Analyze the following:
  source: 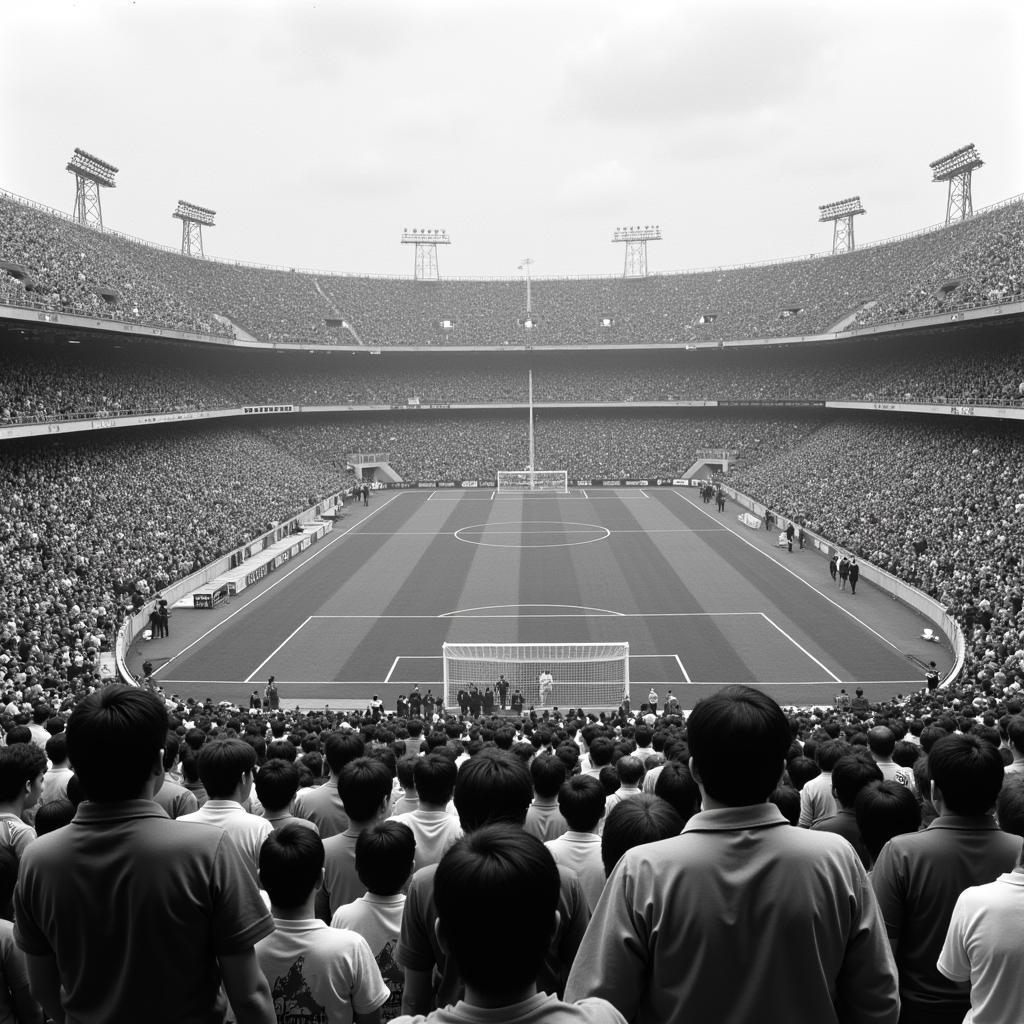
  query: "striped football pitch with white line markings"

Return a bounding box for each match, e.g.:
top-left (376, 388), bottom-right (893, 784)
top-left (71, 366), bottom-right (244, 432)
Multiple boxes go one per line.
top-left (146, 487), bottom-right (951, 709)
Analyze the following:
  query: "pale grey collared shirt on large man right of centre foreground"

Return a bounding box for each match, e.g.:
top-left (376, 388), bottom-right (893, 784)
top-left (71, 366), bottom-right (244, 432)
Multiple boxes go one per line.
top-left (565, 804), bottom-right (899, 1024)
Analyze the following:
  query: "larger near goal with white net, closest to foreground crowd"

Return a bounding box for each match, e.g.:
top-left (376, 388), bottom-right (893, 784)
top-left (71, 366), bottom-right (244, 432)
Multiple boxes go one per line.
top-left (442, 643), bottom-right (630, 709)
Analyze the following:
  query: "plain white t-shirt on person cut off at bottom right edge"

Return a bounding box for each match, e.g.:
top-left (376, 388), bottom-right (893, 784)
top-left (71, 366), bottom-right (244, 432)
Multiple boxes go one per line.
top-left (936, 870), bottom-right (1024, 1024)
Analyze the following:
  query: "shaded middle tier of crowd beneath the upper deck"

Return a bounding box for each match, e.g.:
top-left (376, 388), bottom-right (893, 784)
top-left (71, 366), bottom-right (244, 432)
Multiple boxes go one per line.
top-left (0, 332), bottom-right (1024, 423)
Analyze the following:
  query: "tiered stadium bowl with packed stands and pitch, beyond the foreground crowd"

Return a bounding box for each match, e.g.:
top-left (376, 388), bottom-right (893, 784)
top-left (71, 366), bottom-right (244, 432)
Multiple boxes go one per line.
top-left (0, 165), bottom-right (1024, 710)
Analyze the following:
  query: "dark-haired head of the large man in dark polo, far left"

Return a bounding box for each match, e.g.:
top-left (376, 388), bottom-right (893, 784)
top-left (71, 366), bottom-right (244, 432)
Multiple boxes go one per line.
top-left (67, 685), bottom-right (167, 803)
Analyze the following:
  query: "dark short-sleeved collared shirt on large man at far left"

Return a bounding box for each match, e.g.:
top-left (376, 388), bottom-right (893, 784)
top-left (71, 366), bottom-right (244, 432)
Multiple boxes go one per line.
top-left (14, 800), bottom-right (273, 1024)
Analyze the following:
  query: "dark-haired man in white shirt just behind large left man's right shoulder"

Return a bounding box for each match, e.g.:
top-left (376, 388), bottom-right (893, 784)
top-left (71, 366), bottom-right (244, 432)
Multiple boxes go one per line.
top-left (178, 738), bottom-right (273, 881)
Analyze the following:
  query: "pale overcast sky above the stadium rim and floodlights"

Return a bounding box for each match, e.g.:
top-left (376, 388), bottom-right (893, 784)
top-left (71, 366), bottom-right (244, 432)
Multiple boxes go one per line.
top-left (0, 0), bottom-right (1024, 276)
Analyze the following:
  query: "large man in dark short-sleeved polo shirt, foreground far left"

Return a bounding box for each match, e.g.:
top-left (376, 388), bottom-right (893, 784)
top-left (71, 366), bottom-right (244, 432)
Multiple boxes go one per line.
top-left (14, 686), bottom-right (275, 1024)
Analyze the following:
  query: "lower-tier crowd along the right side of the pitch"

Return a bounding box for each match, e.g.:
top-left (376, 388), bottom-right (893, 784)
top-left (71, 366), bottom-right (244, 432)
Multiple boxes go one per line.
top-left (729, 417), bottom-right (1024, 681)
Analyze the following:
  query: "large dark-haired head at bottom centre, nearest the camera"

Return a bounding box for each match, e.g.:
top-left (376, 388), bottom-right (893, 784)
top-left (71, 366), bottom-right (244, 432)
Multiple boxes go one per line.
top-left (434, 827), bottom-right (560, 995)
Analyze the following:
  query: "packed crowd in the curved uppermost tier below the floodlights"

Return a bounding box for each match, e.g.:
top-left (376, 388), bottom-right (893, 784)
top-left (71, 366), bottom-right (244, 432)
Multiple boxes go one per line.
top-left (0, 195), bottom-right (1024, 347)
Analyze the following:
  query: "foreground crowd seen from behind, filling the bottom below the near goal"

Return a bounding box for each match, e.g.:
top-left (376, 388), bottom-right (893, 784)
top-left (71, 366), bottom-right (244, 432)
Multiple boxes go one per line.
top-left (0, 678), bottom-right (1024, 1024)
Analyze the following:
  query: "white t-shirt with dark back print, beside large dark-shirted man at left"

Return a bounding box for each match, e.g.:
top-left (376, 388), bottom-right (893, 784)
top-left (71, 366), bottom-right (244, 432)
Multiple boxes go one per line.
top-left (256, 918), bottom-right (390, 1024)
